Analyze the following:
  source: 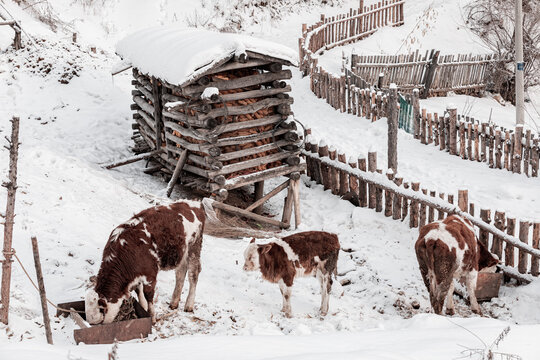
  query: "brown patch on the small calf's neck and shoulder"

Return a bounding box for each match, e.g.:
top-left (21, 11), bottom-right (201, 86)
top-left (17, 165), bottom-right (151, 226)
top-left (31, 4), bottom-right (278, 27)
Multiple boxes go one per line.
top-left (257, 243), bottom-right (296, 286)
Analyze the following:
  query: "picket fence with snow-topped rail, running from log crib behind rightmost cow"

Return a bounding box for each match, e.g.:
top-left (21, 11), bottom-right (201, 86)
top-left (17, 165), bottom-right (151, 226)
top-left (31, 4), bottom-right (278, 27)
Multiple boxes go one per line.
top-left (303, 132), bottom-right (540, 282)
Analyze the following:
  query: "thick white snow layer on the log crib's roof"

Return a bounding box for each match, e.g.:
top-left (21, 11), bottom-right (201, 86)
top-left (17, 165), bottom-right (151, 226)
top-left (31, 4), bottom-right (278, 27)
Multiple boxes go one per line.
top-left (116, 25), bottom-right (298, 85)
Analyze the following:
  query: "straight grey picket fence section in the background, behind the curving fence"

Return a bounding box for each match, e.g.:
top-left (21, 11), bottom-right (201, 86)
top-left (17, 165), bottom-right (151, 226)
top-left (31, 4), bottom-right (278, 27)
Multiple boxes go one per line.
top-left (351, 50), bottom-right (497, 98)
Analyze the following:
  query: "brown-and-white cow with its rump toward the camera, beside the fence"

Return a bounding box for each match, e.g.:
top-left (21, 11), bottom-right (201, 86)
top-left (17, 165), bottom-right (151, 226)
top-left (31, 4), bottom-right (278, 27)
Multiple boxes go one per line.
top-left (415, 215), bottom-right (499, 315)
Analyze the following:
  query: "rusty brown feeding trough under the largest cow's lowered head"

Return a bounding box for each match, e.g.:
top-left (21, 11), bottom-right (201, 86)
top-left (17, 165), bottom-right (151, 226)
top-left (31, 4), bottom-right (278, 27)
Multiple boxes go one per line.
top-left (56, 299), bottom-right (152, 344)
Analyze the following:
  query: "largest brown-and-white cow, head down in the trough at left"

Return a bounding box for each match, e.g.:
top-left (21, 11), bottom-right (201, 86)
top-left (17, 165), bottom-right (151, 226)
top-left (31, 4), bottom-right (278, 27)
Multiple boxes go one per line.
top-left (85, 200), bottom-right (205, 324)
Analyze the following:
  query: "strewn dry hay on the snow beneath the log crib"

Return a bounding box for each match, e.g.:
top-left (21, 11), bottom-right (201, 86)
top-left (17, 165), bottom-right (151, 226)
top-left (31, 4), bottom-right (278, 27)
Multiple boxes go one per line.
top-left (202, 198), bottom-right (281, 239)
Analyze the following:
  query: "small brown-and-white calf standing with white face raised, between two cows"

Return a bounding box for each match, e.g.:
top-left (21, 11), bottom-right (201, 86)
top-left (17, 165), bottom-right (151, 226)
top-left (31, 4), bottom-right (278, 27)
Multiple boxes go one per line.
top-left (244, 231), bottom-right (339, 317)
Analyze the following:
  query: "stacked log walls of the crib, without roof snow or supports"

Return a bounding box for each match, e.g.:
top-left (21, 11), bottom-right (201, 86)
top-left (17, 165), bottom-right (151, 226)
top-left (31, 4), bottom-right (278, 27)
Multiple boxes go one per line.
top-left (132, 53), bottom-right (301, 192)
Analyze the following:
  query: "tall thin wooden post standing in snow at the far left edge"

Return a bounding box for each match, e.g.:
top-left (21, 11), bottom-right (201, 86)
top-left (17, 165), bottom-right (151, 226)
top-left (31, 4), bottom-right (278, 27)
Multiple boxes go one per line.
top-left (0, 116), bottom-right (19, 325)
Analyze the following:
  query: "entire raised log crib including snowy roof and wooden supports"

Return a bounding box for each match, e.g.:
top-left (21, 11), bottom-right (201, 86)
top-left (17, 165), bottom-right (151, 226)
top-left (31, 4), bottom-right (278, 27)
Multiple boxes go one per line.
top-left (117, 26), bottom-right (305, 228)
